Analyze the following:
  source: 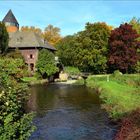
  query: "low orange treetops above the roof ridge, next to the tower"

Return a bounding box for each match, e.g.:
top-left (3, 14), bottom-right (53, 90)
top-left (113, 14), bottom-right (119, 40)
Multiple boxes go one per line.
top-left (21, 26), bottom-right (42, 37)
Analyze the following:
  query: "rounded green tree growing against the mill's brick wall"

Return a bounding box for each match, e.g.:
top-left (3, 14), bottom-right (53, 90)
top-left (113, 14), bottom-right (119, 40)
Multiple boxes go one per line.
top-left (36, 49), bottom-right (58, 78)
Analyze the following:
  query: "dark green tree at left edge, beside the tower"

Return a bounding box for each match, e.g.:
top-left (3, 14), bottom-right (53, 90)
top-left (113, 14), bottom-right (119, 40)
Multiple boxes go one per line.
top-left (0, 22), bottom-right (9, 53)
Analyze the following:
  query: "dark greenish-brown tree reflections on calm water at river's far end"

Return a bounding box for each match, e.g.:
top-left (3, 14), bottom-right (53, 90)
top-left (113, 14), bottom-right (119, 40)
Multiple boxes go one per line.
top-left (29, 85), bottom-right (100, 113)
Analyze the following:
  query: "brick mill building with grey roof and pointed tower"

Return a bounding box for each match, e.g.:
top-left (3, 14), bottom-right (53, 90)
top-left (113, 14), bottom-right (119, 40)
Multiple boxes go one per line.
top-left (2, 10), bottom-right (56, 72)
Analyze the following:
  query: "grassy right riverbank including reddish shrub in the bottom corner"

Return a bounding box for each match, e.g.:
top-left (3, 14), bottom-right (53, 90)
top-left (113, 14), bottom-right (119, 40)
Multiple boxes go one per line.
top-left (86, 75), bottom-right (140, 140)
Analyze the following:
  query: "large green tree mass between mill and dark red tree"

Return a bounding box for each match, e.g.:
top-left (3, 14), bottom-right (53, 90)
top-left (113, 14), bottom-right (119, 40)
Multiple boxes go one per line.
top-left (57, 23), bottom-right (111, 73)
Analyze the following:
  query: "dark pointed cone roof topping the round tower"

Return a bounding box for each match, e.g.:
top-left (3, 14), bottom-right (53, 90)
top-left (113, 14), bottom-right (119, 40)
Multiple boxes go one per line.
top-left (2, 10), bottom-right (19, 25)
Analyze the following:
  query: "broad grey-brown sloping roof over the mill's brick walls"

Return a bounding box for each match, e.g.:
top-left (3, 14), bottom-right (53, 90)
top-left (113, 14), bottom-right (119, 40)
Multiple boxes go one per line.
top-left (9, 31), bottom-right (56, 51)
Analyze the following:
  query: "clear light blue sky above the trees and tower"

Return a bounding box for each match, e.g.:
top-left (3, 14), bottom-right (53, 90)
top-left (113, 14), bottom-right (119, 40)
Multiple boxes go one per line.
top-left (0, 0), bottom-right (140, 36)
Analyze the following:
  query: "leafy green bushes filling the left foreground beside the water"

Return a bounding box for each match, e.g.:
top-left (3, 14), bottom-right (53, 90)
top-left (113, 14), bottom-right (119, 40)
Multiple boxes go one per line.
top-left (0, 58), bottom-right (35, 140)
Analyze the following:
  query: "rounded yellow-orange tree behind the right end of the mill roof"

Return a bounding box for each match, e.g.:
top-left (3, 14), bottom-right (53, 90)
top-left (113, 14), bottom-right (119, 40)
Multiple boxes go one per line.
top-left (43, 25), bottom-right (62, 45)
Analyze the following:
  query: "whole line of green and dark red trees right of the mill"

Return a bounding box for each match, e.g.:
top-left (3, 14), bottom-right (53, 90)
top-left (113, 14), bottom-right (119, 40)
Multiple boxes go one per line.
top-left (56, 18), bottom-right (140, 74)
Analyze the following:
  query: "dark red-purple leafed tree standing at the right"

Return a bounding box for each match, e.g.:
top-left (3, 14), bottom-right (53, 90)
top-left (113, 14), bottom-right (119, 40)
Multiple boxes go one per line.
top-left (108, 23), bottom-right (139, 73)
